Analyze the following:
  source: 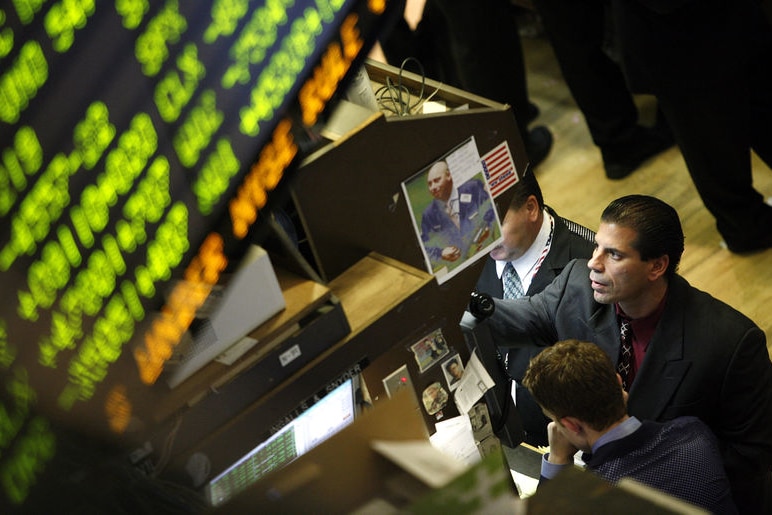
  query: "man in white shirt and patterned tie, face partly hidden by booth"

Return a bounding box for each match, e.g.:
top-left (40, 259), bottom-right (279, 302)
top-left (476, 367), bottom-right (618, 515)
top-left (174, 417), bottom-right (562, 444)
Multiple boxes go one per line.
top-left (476, 172), bottom-right (595, 445)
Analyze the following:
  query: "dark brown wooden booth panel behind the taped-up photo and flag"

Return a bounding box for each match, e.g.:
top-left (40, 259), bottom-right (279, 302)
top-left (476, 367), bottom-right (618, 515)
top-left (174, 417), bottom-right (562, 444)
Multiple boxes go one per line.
top-left (291, 61), bottom-right (527, 284)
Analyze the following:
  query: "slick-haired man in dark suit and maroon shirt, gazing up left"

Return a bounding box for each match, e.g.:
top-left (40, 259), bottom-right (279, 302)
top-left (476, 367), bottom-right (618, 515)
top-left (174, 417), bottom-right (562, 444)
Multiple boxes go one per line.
top-left (482, 195), bottom-right (772, 513)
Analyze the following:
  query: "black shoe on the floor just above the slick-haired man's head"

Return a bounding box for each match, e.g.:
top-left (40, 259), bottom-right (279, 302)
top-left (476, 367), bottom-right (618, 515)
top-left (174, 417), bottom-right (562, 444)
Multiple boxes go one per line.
top-left (601, 125), bottom-right (674, 180)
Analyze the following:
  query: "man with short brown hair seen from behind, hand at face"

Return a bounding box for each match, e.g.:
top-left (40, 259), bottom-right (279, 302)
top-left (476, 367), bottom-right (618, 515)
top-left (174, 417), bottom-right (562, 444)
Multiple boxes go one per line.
top-left (523, 340), bottom-right (736, 514)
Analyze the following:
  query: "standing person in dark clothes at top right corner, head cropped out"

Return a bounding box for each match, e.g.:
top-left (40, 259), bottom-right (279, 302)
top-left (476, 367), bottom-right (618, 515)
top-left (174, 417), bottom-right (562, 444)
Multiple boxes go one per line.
top-left (611, 0), bottom-right (772, 253)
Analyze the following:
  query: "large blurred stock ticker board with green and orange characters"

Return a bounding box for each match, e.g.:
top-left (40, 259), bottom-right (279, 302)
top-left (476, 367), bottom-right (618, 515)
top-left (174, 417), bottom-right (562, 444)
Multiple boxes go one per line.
top-left (0, 0), bottom-right (396, 504)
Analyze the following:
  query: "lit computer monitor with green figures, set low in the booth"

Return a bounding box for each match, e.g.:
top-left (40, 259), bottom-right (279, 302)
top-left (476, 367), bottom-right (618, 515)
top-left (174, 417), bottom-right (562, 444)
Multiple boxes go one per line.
top-left (205, 378), bottom-right (358, 507)
